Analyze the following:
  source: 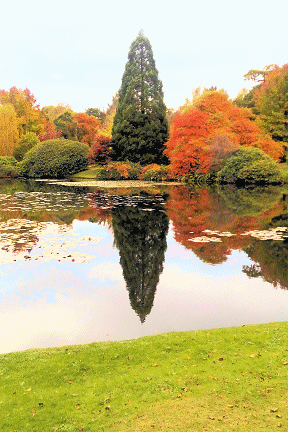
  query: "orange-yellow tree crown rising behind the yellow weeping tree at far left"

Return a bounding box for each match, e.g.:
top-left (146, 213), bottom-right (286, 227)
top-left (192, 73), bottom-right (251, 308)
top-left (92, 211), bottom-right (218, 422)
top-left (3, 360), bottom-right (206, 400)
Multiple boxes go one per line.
top-left (0, 87), bottom-right (43, 135)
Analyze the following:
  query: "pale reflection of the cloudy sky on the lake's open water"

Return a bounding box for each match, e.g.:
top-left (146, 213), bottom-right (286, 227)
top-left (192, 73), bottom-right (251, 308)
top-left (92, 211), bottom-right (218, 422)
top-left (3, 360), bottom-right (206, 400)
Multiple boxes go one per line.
top-left (0, 220), bottom-right (288, 352)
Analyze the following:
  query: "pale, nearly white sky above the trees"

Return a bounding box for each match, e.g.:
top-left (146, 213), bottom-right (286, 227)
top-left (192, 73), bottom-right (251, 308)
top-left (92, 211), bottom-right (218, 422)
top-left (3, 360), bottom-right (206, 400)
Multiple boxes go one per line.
top-left (0, 0), bottom-right (288, 112)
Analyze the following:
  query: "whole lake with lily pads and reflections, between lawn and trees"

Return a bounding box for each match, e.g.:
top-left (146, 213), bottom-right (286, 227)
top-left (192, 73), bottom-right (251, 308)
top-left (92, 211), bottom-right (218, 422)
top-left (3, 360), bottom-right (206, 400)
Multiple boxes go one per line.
top-left (0, 180), bottom-right (288, 353)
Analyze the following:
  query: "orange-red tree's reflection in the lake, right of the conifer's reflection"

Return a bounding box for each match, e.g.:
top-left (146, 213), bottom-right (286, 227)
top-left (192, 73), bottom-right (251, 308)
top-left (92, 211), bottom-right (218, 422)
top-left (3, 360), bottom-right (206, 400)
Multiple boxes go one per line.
top-left (166, 186), bottom-right (281, 264)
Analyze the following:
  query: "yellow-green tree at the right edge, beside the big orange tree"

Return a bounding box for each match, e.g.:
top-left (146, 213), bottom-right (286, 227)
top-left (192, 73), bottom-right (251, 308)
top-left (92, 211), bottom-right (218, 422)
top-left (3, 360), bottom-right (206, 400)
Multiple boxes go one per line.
top-left (256, 64), bottom-right (288, 148)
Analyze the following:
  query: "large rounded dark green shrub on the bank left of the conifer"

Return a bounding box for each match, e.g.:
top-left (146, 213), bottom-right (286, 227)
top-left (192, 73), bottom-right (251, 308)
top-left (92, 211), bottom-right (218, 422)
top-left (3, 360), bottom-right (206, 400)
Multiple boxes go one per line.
top-left (20, 139), bottom-right (89, 178)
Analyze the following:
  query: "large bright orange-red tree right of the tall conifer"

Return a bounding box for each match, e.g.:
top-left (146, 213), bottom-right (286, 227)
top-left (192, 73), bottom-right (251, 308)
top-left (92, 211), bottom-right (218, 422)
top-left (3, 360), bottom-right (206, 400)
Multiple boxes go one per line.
top-left (165, 90), bottom-right (283, 175)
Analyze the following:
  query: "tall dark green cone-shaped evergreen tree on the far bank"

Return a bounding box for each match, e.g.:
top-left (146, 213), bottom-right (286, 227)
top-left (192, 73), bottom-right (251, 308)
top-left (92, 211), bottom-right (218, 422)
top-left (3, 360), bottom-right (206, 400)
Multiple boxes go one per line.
top-left (112, 31), bottom-right (168, 165)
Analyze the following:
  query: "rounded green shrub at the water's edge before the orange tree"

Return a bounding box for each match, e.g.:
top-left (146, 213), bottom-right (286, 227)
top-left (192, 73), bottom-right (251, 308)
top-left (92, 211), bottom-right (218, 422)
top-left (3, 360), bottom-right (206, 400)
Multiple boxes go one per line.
top-left (217, 147), bottom-right (282, 184)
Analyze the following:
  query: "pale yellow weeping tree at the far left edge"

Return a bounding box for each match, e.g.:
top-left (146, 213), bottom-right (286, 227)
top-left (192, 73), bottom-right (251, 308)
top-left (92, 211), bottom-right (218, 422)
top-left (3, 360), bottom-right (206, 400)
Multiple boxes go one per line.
top-left (0, 103), bottom-right (19, 156)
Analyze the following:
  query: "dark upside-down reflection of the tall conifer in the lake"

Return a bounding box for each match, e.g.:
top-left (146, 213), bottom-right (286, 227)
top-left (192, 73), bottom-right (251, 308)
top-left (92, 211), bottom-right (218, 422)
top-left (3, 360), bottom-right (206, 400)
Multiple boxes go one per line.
top-left (112, 196), bottom-right (169, 323)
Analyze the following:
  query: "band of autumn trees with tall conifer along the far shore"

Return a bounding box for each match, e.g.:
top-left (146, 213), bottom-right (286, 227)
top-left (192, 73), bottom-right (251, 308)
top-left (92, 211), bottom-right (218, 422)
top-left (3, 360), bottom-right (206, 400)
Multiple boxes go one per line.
top-left (0, 32), bottom-right (288, 183)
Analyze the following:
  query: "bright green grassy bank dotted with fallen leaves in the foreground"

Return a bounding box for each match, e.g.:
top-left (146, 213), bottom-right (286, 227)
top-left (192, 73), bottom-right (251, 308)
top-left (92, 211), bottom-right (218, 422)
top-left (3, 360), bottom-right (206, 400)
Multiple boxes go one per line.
top-left (0, 323), bottom-right (288, 432)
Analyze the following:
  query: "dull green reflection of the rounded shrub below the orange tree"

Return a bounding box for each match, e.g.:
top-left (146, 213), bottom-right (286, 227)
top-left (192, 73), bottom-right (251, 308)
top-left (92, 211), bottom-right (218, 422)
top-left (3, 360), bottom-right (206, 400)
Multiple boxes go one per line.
top-left (218, 185), bottom-right (281, 216)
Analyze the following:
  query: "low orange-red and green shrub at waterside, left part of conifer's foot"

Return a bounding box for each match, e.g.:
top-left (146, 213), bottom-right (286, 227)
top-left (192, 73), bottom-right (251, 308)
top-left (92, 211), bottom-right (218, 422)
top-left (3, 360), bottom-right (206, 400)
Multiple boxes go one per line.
top-left (98, 161), bottom-right (141, 180)
